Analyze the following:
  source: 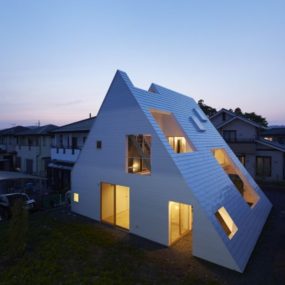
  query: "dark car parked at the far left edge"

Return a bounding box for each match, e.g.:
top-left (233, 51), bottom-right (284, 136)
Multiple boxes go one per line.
top-left (0, 193), bottom-right (35, 221)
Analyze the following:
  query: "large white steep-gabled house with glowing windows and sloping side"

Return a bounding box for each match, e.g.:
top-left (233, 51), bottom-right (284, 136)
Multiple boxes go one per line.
top-left (72, 71), bottom-right (271, 272)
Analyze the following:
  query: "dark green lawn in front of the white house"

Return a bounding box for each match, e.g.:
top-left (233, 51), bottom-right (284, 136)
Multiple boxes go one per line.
top-left (0, 209), bottom-right (218, 285)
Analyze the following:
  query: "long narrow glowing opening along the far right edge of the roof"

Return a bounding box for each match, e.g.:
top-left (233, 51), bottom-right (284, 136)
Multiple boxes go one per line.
top-left (213, 148), bottom-right (259, 206)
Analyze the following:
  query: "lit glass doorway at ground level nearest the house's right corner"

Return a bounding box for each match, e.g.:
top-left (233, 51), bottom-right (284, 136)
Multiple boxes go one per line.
top-left (168, 201), bottom-right (193, 245)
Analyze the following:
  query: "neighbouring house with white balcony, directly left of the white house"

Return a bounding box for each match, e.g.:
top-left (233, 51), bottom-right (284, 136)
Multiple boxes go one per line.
top-left (48, 117), bottom-right (95, 190)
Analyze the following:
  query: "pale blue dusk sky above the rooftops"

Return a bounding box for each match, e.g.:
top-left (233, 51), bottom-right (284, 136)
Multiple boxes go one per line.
top-left (0, 0), bottom-right (285, 128)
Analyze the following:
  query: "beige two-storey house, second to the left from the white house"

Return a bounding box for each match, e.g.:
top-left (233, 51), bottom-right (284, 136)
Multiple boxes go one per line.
top-left (15, 125), bottom-right (57, 177)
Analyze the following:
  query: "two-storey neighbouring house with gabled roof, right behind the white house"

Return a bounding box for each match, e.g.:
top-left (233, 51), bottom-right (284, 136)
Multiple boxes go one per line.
top-left (210, 109), bottom-right (285, 181)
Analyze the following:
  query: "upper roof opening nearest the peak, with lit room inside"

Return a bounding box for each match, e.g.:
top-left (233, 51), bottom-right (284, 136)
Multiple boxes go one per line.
top-left (150, 110), bottom-right (194, 153)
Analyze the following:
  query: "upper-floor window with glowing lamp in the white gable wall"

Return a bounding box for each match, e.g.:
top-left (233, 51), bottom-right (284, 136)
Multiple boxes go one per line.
top-left (127, 135), bottom-right (151, 175)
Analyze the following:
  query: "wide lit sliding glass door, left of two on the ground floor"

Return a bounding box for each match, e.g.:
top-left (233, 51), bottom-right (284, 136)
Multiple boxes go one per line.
top-left (101, 183), bottom-right (130, 229)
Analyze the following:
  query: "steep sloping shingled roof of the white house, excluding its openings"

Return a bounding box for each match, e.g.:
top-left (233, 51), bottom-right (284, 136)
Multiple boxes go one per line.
top-left (114, 72), bottom-right (271, 271)
